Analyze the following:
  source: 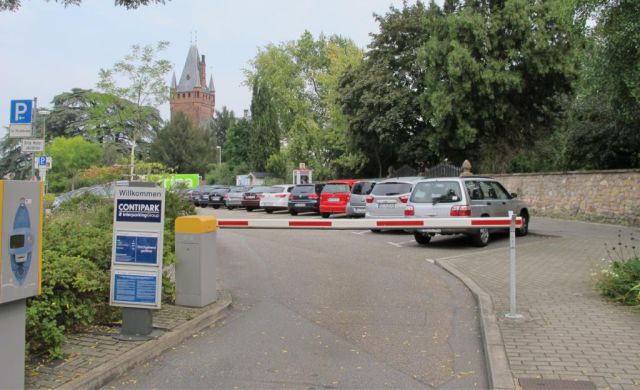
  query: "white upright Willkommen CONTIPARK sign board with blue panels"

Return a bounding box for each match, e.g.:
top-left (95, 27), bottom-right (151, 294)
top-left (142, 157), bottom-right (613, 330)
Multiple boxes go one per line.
top-left (111, 182), bottom-right (165, 309)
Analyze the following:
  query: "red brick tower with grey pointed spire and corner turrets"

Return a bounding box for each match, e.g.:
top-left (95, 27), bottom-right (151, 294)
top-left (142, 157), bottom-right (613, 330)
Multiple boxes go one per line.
top-left (169, 45), bottom-right (216, 125)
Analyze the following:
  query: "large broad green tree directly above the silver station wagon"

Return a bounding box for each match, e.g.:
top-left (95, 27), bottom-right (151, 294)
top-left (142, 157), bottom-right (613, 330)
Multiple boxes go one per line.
top-left (419, 0), bottom-right (576, 171)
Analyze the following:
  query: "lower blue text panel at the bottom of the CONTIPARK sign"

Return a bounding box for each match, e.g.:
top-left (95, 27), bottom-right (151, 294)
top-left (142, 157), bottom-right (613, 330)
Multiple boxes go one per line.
top-left (112, 270), bottom-right (158, 305)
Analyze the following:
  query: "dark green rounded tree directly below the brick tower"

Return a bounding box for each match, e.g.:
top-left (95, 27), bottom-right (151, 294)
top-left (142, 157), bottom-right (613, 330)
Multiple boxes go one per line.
top-left (150, 112), bottom-right (215, 175)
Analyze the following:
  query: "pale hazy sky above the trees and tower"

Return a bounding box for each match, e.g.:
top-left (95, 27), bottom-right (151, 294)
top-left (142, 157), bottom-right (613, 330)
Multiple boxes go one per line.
top-left (0, 0), bottom-right (412, 135)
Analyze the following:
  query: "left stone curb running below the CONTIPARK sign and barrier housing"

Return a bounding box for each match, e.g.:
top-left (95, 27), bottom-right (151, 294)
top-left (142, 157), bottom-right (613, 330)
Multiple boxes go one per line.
top-left (58, 291), bottom-right (232, 390)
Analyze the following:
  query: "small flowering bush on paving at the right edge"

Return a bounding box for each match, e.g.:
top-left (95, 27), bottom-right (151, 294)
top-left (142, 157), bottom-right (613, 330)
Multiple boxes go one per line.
top-left (597, 234), bottom-right (640, 308)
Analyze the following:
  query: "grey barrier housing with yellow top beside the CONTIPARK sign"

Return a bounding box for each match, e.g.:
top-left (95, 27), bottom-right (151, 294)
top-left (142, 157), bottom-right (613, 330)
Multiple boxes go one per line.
top-left (175, 215), bottom-right (218, 307)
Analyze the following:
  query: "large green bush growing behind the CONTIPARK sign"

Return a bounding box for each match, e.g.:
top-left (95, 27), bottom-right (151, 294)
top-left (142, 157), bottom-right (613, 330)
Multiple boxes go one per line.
top-left (27, 192), bottom-right (195, 358)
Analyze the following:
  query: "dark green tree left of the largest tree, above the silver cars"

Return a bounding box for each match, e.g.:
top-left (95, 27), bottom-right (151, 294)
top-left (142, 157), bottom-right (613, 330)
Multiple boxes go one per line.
top-left (337, 2), bottom-right (441, 177)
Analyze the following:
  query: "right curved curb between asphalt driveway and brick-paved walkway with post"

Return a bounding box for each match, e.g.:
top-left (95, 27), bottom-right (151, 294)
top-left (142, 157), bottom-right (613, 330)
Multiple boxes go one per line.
top-left (435, 260), bottom-right (517, 390)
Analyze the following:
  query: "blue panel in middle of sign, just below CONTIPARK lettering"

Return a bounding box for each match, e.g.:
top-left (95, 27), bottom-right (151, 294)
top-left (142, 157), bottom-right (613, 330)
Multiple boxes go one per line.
top-left (115, 231), bottom-right (158, 265)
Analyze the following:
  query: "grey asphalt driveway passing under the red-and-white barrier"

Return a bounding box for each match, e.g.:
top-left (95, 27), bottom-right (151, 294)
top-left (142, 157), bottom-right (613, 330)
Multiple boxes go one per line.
top-left (105, 209), bottom-right (504, 389)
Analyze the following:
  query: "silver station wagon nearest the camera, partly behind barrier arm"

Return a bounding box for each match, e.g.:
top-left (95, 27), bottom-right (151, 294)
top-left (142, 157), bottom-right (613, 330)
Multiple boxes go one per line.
top-left (405, 176), bottom-right (530, 247)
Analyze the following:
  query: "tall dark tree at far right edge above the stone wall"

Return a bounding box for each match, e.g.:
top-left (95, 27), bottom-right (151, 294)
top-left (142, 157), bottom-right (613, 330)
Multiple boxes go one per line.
top-left (567, 0), bottom-right (640, 169)
